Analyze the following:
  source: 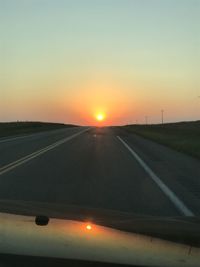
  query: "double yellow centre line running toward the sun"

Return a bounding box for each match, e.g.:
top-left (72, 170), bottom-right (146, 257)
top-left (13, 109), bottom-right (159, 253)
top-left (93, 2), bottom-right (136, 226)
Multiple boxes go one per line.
top-left (0, 128), bottom-right (90, 175)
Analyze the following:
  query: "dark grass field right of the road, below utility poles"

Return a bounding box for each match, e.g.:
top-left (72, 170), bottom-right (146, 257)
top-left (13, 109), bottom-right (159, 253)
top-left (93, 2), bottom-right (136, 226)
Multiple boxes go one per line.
top-left (123, 121), bottom-right (200, 159)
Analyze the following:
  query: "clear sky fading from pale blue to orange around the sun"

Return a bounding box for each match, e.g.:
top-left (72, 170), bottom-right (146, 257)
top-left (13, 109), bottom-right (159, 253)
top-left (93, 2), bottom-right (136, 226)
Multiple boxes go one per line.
top-left (0, 0), bottom-right (200, 125)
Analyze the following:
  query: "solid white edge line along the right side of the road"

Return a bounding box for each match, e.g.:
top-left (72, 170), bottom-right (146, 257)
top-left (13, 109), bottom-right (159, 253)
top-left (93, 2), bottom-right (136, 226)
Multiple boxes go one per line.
top-left (117, 136), bottom-right (194, 216)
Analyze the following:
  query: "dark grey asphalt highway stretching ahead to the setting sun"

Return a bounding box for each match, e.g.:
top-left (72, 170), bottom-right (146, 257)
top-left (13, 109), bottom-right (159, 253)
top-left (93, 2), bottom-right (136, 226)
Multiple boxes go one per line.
top-left (0, 127), bottom-right (200, 216)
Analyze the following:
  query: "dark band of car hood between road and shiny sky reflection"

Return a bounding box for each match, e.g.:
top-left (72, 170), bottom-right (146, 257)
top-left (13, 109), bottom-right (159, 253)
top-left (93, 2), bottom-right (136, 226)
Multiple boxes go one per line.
top-left (0, 200), bottom-right (200, 247)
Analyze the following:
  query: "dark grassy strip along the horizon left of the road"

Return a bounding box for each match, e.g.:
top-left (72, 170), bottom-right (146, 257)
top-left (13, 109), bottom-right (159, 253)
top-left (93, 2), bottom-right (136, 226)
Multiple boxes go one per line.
top-left (0, 122), bottom-right (77, 137)
